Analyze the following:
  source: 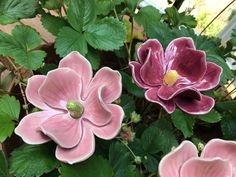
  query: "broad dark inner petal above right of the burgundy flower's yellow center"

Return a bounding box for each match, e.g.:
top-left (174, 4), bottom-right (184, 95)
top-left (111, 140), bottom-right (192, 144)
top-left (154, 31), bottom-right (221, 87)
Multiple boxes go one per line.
top-left (170, 49), bottom-right (207, 82)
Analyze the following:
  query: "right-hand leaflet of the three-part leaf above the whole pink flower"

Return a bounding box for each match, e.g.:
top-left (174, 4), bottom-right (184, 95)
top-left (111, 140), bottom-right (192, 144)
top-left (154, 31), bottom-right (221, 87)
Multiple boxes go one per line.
top-left (85, 17), bottom-right (126, 50)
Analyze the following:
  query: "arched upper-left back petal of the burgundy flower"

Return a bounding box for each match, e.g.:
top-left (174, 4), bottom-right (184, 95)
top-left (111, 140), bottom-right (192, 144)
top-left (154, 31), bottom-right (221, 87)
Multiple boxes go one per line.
top-left (137, 39), bottom-right (164, 64)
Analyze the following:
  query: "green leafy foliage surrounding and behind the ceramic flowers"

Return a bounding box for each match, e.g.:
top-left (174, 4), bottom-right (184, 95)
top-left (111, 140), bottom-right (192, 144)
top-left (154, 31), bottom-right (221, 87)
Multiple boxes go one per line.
top-left (0, 0), bottom-right (236, 177)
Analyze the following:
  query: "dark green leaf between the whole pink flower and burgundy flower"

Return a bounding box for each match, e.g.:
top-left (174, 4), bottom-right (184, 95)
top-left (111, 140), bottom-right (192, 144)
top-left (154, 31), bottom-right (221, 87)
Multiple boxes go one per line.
top-left (120, 71), bottom-right (144, 98)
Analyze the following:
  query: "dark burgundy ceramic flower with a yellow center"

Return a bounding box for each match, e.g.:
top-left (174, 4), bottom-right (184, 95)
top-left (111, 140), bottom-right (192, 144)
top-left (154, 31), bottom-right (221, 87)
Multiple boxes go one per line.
top-left (130, 37), bottom-right (222, 114)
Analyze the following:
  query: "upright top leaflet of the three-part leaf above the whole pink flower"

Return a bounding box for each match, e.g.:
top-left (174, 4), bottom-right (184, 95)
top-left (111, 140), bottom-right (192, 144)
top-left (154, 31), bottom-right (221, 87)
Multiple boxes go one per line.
top-left (67, 0), bottom-right (96, 32)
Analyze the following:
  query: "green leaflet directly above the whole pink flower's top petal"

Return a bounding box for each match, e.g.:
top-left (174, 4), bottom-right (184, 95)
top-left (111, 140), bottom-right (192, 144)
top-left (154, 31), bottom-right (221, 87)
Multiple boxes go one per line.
top-left (55, 27), bottom-right (88, 57)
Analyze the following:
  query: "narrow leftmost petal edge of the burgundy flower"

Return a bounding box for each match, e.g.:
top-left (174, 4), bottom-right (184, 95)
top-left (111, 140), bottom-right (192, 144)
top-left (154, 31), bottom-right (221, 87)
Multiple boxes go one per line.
top-left (129, 61), bottom-right (150, 89)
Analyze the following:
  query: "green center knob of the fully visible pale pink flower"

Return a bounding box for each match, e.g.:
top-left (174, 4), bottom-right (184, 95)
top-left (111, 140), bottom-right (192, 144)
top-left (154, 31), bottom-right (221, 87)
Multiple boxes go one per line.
top-left (66, 101), bottom-right (84, 119)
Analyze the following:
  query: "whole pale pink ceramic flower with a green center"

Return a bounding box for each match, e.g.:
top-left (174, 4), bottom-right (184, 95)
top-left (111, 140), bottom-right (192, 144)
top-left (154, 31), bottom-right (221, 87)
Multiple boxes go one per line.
top-left (15, 52), bottom-right (124, 164)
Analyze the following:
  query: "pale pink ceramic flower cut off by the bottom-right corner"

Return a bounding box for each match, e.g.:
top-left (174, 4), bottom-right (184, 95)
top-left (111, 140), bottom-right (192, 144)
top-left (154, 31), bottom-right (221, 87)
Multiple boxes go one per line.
top-left (159, 139), bottom-right (236, 177)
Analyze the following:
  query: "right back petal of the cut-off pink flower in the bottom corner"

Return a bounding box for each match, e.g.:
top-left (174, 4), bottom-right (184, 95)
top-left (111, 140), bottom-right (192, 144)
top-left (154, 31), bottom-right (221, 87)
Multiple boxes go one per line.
top-left (201, 139), bottom-right (236, 175)
